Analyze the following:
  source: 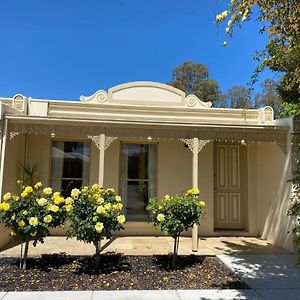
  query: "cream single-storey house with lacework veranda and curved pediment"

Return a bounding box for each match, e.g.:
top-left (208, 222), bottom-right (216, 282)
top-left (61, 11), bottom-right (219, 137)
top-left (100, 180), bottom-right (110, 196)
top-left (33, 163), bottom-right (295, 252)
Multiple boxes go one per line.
top-left (0, 82), bottom-right (296, 250)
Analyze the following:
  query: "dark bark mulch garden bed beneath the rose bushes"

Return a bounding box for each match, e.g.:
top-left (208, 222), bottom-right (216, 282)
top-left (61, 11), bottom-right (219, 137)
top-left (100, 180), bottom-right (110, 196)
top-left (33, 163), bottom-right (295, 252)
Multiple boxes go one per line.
top-left (0, 254), bottom-right (248, 291)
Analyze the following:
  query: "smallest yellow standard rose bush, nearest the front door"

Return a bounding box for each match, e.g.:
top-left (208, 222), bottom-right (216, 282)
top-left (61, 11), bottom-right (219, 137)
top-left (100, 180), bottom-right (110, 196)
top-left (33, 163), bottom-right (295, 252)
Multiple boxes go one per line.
top-left (147, 188), bottom-right (205, 268)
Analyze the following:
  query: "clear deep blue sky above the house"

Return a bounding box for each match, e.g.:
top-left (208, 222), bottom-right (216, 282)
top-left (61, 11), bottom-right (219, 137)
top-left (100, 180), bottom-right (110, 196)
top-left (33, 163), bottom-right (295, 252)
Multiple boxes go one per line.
top-left (0, 0), bottom-right (271, 100)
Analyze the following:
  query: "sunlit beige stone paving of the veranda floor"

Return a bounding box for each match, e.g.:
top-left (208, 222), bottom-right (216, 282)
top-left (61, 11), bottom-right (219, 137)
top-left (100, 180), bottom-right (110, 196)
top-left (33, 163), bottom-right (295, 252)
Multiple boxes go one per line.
top-left (0, 236), bottom-right (288, 257)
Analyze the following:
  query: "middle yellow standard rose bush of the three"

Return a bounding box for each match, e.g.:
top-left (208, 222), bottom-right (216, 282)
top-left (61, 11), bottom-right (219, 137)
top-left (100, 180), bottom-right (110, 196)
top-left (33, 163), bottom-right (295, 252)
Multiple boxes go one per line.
top-left (68, 184), bottom-right (125, 268)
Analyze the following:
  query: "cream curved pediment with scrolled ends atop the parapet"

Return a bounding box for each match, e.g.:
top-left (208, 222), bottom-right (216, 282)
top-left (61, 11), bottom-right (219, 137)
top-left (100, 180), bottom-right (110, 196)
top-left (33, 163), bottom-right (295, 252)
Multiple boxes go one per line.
top-left (80, 81), bottom-right (211, 108)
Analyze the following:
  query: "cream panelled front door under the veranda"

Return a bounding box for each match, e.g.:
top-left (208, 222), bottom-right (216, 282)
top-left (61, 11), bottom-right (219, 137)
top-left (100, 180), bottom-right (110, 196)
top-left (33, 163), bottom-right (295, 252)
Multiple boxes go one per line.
top-left (214, 143), bottom-right (247, 230)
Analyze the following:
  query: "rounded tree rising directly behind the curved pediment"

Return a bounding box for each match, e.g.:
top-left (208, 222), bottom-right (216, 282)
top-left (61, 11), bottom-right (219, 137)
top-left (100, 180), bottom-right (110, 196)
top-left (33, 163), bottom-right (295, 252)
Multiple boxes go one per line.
top-left (168, 61), bottom-right (220, 102)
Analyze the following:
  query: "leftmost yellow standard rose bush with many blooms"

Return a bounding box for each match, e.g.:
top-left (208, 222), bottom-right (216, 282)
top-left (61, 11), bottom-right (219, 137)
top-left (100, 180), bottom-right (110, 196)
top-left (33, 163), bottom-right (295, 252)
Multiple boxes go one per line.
top-left (0, 181), bottom-right (70, 269)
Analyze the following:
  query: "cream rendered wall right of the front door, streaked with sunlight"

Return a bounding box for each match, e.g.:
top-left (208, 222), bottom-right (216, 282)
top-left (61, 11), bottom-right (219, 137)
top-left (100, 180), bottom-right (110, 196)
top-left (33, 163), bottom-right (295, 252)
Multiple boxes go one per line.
top-left (258, 143), bottom-right (293, 250)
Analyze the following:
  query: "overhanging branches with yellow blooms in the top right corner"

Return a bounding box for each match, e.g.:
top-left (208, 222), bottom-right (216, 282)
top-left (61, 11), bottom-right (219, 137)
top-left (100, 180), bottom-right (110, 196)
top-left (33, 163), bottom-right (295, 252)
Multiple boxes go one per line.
top-left (216, 0), bottom-right (300, 103)
